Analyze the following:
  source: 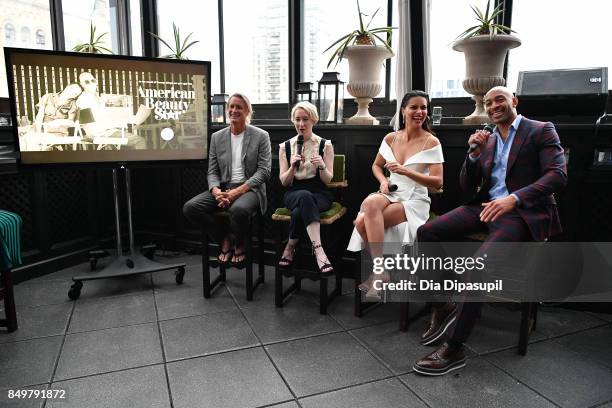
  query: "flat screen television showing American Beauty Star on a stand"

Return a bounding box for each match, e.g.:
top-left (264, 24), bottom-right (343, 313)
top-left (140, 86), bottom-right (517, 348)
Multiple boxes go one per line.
top-left (4, 48), bottom-right (210, 164)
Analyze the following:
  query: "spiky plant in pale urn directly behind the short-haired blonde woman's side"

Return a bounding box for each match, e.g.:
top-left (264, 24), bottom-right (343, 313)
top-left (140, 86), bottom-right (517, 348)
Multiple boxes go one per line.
top-left (324, 0), bottom-right (395, 125)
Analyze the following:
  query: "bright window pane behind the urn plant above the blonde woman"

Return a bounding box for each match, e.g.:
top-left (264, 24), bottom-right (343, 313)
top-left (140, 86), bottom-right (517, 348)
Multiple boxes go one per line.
top-left (303, 0), bottom-right (387, 97)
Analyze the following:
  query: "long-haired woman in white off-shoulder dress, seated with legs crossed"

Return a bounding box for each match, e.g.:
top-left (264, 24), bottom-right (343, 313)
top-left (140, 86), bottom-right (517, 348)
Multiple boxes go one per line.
top-left (348, 91), bottom-right (444, 297)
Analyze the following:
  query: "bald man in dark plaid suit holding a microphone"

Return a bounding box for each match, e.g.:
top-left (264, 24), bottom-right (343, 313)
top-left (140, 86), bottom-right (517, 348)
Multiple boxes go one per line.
top-left (414, 87), bottom-right (567, 375)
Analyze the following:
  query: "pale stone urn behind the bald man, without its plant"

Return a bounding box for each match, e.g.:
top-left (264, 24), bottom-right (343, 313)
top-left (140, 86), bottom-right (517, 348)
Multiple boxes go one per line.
top-left (453, 34), bottom-right (521, 125)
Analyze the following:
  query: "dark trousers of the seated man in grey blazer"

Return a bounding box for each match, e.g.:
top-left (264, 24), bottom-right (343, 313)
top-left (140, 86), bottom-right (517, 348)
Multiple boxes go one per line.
top-left (183, 191), bottom-right (259, 244)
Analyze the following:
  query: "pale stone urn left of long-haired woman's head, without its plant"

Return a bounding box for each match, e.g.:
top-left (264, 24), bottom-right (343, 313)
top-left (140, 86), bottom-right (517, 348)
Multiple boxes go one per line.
top-left (344, 45), bottom-right (395, 125)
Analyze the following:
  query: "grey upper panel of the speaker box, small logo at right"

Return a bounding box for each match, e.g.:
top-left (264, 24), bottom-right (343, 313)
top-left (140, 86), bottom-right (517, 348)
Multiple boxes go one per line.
top-left (516, 67), bottom-right (608, 96)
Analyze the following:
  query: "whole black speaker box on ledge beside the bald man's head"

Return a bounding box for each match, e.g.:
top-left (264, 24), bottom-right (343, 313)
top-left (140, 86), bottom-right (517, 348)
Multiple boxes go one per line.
top-left (516, 67), bottom-right (608, 123)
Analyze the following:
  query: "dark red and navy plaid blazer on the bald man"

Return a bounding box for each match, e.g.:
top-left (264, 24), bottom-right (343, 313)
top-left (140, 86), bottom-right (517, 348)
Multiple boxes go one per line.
top-left (460, 117), bottom-right (567, 241)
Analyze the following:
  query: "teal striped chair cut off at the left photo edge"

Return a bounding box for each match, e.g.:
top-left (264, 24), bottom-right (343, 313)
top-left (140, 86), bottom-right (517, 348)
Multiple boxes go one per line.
top-left (0, 210), bottom-right (22, 332)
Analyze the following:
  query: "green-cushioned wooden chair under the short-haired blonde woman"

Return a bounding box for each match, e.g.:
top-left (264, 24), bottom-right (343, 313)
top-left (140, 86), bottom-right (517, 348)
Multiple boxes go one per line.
top-left (272, 154), bottom-right (348, 314)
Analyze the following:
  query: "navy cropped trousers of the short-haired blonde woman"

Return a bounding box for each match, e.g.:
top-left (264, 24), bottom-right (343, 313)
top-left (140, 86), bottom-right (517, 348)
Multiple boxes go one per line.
top-left (284, 190), bottom-right (332, 239)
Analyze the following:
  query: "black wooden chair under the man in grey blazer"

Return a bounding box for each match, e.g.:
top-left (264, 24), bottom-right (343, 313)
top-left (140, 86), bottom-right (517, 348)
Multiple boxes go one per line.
top-left (202, 209), bottom-right (265, 301)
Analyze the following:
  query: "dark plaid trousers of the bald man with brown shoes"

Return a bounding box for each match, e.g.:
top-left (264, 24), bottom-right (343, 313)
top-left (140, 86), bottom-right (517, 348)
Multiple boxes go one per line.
top-left (417, 205), bottom-right (532, 343)
